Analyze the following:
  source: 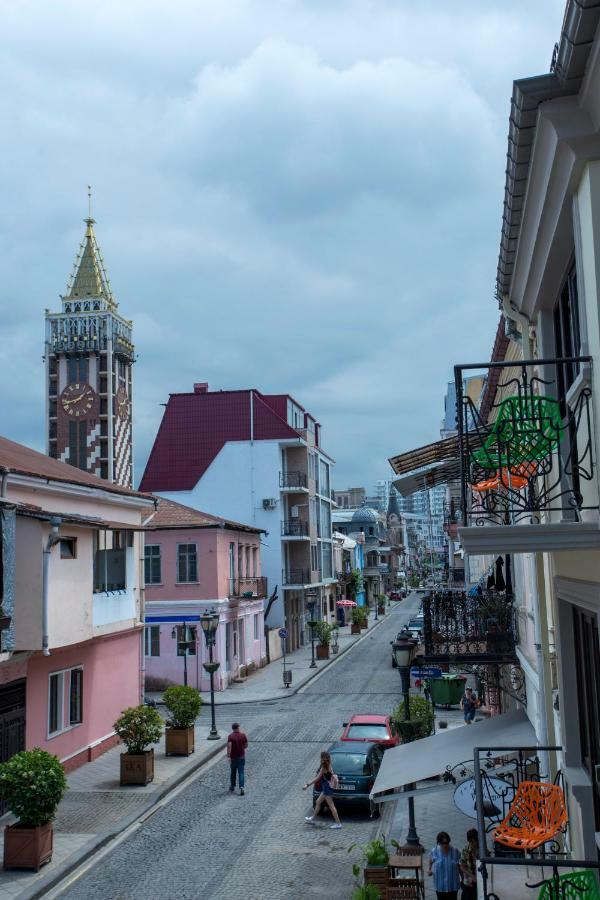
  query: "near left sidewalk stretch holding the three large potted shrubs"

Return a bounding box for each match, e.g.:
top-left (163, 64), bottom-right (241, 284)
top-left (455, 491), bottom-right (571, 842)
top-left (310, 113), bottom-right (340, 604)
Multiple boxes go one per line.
top-left (0, 713), bottom-right (225, 900)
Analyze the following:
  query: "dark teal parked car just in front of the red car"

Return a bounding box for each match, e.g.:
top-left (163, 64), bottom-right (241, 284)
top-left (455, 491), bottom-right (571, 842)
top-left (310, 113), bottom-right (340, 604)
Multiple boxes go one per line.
top-left (313, 741), bottom-right (385, 817)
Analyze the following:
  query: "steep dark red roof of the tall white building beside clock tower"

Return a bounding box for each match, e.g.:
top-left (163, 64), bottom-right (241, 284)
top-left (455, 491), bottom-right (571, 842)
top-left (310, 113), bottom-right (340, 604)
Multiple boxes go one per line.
top-left (140, 390), bottom-right (298, 491)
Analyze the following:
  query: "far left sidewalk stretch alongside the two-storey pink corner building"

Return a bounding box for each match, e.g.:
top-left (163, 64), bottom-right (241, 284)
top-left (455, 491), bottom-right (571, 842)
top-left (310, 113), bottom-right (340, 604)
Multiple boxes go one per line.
top-left (146, 604), bottom-right (386, 706)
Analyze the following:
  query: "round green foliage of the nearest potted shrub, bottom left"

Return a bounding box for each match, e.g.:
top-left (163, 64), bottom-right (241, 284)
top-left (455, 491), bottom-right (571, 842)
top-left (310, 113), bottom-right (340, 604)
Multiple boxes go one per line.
top-left (0, 747), bottom-right (67, 828)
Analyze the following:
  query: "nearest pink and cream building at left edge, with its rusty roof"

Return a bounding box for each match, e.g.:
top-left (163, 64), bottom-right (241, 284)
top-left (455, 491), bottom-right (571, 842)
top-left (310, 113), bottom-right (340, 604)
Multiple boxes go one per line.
top-left (0, 438), bottom-right (154, 768)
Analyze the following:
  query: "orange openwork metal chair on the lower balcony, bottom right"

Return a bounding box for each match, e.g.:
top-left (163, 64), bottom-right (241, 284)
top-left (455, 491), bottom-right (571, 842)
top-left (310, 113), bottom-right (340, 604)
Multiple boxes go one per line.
top-left (493, 781), bottom-right (568, 851)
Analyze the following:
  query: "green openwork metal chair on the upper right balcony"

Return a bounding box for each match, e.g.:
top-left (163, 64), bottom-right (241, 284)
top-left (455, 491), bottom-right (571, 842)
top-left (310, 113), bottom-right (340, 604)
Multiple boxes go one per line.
top-left (471, 394), bottom-right (564, 471)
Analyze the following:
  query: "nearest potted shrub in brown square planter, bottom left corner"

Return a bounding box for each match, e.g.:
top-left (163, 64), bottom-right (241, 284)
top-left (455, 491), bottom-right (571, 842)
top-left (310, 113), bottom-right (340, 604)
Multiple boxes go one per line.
top-left (0, 747), bottom-right (67, 872)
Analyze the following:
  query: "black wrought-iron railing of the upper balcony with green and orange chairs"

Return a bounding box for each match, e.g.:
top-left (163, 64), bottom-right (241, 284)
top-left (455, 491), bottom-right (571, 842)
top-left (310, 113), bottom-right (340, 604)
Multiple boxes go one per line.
top-left (455, 356), bottom-right (599, 526)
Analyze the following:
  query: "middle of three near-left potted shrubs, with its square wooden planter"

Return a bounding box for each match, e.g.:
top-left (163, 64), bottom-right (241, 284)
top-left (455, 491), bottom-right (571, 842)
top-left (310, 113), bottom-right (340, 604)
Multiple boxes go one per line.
top-left (114, 705), bottom-right (163, 784)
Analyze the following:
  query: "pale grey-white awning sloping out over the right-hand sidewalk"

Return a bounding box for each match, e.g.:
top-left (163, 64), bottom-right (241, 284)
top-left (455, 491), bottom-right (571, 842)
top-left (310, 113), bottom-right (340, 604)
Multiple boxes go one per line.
top-left (371, 709), bottom-right (537, 801)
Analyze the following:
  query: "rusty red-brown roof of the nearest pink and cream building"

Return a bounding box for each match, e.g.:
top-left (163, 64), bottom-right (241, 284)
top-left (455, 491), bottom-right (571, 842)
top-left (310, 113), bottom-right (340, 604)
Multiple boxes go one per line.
top-left (0, 437), bottom-right (153, 500)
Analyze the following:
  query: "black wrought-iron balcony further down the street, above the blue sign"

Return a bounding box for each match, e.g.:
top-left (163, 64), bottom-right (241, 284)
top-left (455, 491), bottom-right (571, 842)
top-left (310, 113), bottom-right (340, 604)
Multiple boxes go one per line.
top-left (423, 590), bottom-right (518, 664)
